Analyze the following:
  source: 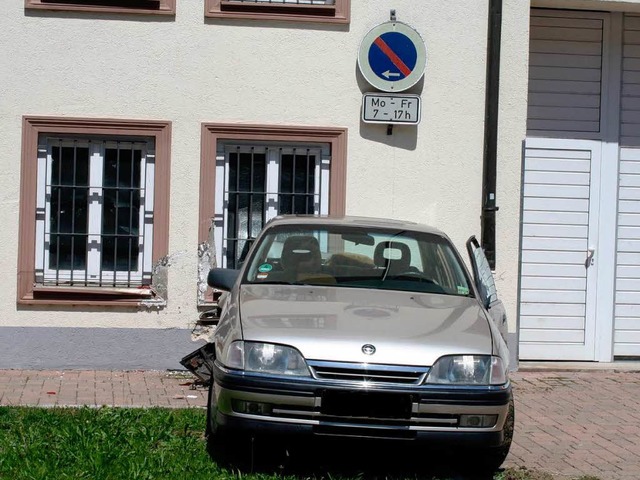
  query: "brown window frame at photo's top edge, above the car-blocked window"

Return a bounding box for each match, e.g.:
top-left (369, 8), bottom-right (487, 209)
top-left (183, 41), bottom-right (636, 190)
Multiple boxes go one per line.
top-left (204, 0), bottom-right (351, 24)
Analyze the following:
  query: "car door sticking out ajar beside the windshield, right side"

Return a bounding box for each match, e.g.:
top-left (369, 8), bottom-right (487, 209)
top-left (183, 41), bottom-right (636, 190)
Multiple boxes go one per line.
top-left (467, 236), bottom-right (507, 342)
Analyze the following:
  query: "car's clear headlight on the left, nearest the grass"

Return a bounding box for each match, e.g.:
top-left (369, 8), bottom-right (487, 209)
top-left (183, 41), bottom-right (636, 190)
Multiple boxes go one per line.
top-left (224, 340), bottom-right (311, 377)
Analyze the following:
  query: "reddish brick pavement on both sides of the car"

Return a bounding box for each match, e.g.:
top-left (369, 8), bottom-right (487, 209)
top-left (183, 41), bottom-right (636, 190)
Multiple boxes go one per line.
top-left (0, 370), bottom-right (640, 480)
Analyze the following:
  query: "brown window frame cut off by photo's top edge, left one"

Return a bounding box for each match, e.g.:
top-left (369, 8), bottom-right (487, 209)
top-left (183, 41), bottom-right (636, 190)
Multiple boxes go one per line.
top-left (24, 0), bottom-right (176, 15)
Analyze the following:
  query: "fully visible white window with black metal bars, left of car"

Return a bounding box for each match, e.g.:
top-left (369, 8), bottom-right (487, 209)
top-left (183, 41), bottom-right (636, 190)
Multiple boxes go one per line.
top-left (35, 137), bottom-right (154, 287)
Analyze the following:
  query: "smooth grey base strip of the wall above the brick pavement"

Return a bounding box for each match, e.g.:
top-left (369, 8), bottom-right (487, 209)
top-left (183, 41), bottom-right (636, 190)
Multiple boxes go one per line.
top-left (0, 327), bottom-right (204, 370)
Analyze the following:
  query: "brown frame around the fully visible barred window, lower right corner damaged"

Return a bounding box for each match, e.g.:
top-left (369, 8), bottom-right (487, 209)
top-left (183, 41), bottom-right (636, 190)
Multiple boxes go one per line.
top-left (17, 116), bottom-right (171, 306)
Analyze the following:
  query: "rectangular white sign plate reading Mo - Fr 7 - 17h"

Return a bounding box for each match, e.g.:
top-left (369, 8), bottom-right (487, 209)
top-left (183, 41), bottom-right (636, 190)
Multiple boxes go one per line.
top-left (362, 93), bottom-right (420, 125)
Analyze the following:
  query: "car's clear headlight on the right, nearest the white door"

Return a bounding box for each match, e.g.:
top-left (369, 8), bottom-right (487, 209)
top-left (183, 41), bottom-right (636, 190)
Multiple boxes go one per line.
top-left (426, 355), bottom-right (507, 385)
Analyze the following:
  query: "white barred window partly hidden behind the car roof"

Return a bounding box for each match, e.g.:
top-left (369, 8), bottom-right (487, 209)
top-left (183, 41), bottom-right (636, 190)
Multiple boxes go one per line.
top-left (215, 143), bottom-right (330, 268)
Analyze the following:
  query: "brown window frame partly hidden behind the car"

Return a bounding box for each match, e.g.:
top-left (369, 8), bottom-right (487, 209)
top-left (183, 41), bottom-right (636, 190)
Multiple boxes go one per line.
top-left (198, 123), bottom-right (348, 243)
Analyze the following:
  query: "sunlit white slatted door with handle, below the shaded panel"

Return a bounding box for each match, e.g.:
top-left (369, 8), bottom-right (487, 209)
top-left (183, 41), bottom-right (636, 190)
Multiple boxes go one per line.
top-left (520, 138), bottom-right (601, 360)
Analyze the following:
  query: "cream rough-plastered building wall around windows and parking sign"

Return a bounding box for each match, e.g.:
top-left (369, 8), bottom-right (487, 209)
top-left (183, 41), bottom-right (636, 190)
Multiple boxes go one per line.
top-left (0, 0), bottom-right (528, 356)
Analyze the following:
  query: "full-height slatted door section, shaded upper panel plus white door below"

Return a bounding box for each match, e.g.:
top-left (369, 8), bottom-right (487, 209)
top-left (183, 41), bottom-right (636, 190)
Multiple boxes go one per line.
top-left (519, 9), bottom-right (608, 360)
